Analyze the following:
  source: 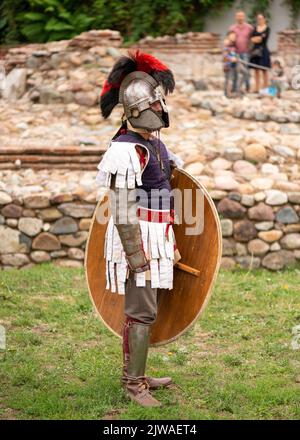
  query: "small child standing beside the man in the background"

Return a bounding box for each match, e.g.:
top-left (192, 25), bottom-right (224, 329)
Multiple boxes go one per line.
top-left (223, 31), bottom-right (237, 98)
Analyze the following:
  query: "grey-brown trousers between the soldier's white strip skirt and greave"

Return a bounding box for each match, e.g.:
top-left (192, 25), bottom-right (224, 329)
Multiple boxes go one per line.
top-left (124, 272), bottom-right (157, 325)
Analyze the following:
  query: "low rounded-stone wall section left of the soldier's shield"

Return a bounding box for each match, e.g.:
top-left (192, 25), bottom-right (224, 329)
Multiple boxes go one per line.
top-left (0, 192), bottom-right (95, 269)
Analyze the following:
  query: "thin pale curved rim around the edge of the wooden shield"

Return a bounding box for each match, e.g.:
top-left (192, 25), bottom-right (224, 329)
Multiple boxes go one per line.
top-left (84, 168), bottom-right (223, 347)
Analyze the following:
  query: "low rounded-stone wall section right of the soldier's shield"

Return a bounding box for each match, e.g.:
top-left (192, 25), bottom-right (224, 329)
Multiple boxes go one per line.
top-left (212, 190), bottom-right (300, 270)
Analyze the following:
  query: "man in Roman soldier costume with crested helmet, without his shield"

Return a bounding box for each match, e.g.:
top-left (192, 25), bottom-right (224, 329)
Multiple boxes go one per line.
top-left (96, 51), bottom-right (182, 406)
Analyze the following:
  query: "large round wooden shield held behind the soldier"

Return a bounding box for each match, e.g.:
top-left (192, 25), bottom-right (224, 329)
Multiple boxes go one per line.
top-left (85, 169), bottom-right (222, 346)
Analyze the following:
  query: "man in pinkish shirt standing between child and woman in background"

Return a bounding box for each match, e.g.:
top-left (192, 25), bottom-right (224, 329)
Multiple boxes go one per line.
top-left (229, 11), bottom-right (253, 92)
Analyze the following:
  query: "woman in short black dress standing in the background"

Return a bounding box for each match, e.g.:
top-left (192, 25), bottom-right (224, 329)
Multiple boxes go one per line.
top-left (250, 14), bottom-right (271, 93)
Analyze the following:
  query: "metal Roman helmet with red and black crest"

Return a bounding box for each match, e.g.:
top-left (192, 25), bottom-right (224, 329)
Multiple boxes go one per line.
top-left (100, 50), bottom-right (175, 132)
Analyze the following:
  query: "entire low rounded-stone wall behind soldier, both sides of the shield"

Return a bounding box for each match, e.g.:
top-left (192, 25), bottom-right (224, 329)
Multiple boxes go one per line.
top-left (0, 186), bottom-right (300, 270)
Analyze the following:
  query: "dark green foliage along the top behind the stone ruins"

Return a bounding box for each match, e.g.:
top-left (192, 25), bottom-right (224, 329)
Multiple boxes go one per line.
top-left (0, 0), bottom-right (300, 44)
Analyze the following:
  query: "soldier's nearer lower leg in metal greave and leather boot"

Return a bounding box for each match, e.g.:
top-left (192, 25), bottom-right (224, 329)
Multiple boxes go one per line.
top-left (122, 319), bottom-right (161, 407)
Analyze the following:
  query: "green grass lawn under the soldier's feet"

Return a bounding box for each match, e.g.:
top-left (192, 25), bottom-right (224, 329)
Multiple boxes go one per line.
top-left (0, 264), bottom-right (300, 419)
